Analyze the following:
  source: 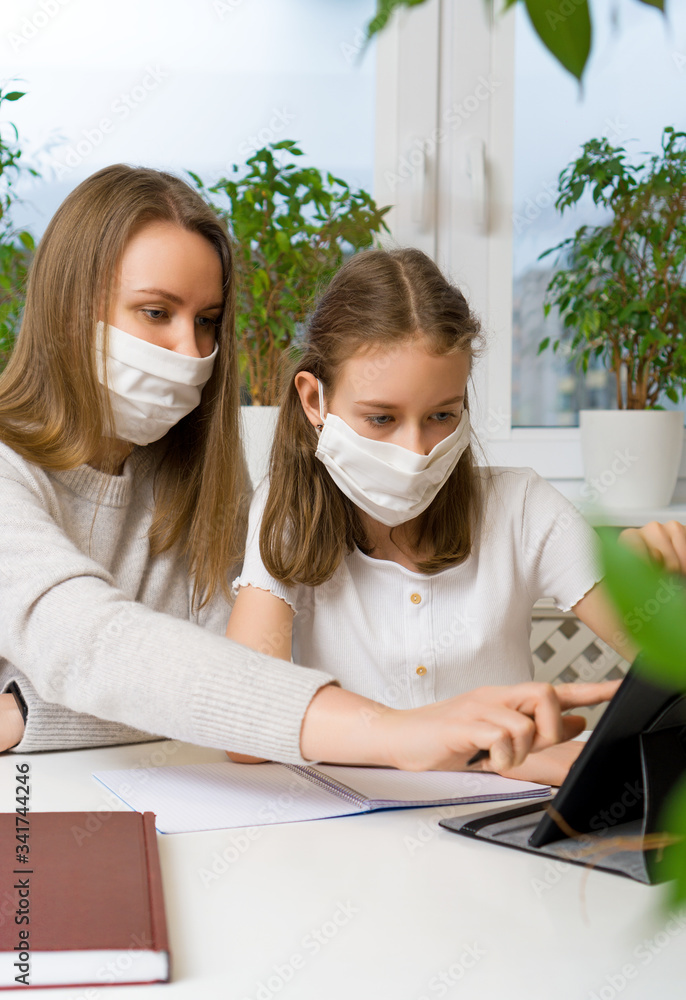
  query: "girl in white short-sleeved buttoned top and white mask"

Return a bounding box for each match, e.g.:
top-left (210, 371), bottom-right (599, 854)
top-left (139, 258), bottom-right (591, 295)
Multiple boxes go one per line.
top-left (227, 249), bottom-right (686, 783)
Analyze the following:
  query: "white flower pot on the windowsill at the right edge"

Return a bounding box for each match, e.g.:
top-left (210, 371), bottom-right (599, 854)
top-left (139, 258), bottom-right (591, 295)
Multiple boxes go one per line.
top-left (579, 410), bottom-right (684, 510)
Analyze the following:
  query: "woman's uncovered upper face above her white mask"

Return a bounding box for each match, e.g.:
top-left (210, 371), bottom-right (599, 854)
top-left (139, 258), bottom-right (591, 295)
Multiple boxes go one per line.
top-left (109, 222), bottom-right (224, 358)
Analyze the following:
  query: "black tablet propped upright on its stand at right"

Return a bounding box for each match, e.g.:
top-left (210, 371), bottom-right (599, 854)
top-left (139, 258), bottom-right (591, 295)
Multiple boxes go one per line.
top-left (528, 660), bottom-right (686, 847)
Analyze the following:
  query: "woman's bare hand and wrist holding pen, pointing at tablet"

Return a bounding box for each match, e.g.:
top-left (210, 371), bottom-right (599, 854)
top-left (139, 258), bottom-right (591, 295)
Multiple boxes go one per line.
top-left (300, 681), bottom-right (619, 771)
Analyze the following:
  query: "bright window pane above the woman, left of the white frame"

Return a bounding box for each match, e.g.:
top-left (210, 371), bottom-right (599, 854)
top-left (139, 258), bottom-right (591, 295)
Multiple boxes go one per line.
top-left (0, 0), bottom-right (375, 235)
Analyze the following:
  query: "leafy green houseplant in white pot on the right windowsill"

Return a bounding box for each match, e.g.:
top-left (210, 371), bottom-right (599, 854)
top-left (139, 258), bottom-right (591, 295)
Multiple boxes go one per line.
top-left (539, 127), bottom-right (686, 507)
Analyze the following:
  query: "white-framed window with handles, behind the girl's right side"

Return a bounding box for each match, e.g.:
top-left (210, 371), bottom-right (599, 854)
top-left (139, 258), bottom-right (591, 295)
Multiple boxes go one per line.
top-left (375, 0), bottom-right (686, 480)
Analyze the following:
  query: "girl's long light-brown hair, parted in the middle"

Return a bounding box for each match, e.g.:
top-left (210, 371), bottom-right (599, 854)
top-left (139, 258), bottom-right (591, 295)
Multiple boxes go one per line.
top-left (260, 249), bottom-right (481, 586)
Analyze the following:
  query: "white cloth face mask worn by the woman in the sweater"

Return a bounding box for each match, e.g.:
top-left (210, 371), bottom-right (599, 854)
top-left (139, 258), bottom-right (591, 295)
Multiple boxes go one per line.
top-left (95, 322), bottom-right (219, 444)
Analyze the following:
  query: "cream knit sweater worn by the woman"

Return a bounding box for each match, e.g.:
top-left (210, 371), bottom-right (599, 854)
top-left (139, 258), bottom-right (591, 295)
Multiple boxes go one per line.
top-left (0, 443), bottom-right (331, 763)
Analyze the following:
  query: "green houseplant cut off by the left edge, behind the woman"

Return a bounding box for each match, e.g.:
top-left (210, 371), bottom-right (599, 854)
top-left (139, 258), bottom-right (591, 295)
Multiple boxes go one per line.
top-left (0, 90), bottom-right (38, 370)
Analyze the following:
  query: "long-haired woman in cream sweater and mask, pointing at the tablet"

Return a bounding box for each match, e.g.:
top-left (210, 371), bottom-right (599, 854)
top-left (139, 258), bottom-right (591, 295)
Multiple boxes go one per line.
top-left (0, 165), bottom-right (611, 769)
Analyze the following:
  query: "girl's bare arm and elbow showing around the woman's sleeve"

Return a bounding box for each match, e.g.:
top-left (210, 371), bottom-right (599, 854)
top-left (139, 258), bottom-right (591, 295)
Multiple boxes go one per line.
top-left (226, 586), bottom-right (293, 764)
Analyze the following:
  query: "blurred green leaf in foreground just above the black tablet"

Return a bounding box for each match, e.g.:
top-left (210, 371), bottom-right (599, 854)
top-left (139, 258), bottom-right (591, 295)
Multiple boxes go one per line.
top-left (598, 528), bottom-right (686, 690)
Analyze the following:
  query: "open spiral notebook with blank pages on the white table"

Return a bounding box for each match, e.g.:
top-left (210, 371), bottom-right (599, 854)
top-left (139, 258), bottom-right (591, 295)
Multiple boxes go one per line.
top-left (93, 761), bottom-right (550, 833)
